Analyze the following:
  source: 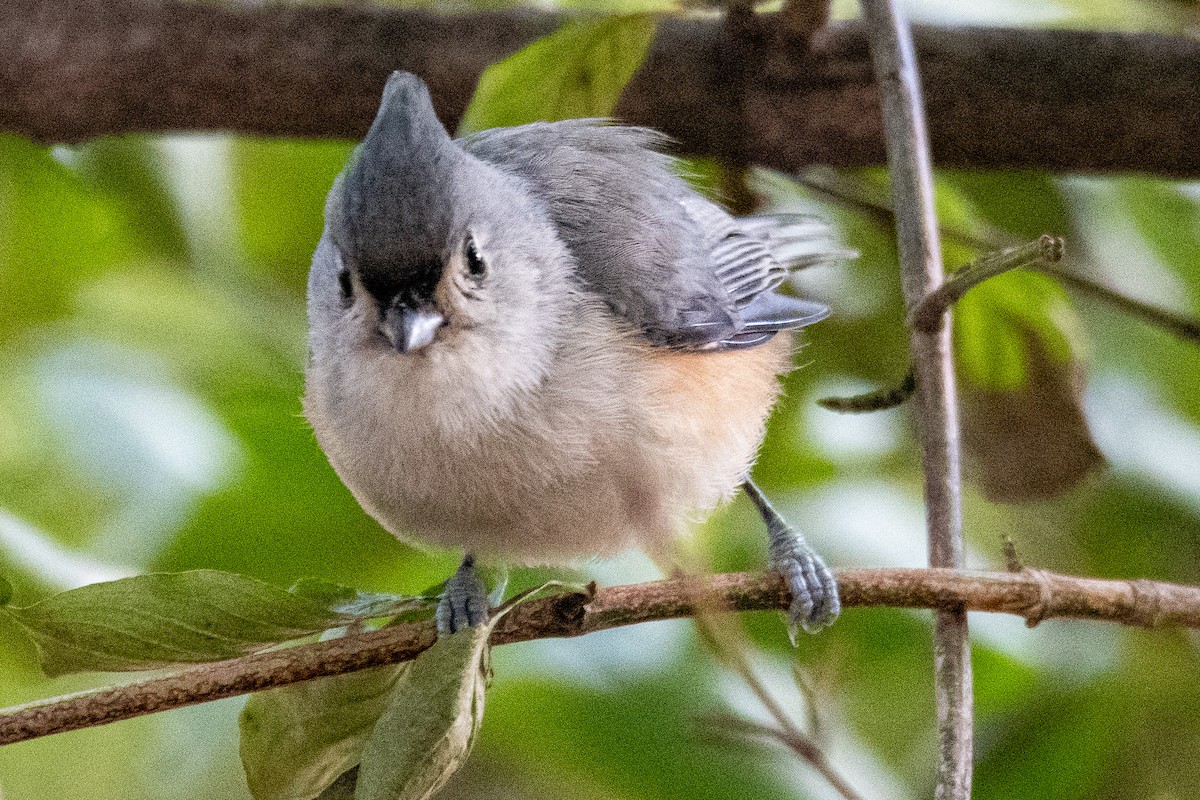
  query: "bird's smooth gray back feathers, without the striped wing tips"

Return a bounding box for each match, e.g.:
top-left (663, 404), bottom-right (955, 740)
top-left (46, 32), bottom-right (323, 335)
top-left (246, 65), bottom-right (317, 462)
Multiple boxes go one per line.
top-left (461, 120), bottom-right (758, 348)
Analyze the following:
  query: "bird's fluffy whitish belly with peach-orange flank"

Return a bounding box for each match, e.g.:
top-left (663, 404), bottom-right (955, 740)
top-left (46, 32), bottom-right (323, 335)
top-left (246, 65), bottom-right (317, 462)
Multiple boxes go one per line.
top-left (306, 331), bottom-right (787, 564)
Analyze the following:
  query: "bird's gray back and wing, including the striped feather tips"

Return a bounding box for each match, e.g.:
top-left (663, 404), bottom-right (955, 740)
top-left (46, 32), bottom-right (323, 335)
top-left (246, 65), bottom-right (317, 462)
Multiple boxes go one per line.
top-left (460, 120), bottom-right (828, 350)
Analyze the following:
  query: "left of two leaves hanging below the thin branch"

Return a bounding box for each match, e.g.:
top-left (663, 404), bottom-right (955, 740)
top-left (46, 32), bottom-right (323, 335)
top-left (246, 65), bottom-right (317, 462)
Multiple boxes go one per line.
top-left (239, 664), bottom-right (409, 800)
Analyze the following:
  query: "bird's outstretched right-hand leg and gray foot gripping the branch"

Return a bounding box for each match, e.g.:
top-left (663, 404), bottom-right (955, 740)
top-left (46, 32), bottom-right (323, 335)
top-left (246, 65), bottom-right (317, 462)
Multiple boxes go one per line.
top-left (742, 480), bottom-right (841, 644)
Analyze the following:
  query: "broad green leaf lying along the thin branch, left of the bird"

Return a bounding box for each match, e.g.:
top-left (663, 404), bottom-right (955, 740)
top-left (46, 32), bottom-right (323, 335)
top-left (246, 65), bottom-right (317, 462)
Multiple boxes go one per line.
top-left (4, 570), bottom-right (354, 675)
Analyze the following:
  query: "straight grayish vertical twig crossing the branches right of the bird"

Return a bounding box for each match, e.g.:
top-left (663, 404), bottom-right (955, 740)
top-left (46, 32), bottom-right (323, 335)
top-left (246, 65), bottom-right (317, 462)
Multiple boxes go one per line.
top-left (863, 0), bottom-right (972, 800)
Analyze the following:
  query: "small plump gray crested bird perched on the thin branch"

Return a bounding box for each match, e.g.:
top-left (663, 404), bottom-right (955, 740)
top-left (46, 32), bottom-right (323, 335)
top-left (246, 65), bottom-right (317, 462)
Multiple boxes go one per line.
top-left (305, 72), bottom-right (839, 632)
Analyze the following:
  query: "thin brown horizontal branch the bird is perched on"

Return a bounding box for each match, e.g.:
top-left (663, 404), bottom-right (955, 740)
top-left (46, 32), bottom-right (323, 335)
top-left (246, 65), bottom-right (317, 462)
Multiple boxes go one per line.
top-left (0, 569), bottom-right (1200, 745)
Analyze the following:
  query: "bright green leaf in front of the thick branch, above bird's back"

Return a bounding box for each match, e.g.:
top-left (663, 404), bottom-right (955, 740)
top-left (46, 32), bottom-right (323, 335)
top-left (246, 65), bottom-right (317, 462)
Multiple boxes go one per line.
top-left (458, 14), bottom-right (658, 134)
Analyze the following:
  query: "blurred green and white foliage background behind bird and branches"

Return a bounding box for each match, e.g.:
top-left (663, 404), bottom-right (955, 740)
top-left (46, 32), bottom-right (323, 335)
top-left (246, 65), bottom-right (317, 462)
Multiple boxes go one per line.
top-left (0, 0), bottom-right (1200, 800)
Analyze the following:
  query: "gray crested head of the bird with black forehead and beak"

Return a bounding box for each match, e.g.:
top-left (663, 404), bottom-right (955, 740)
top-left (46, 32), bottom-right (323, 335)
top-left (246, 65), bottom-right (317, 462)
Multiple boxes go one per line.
top-left (311, 72), bottom-right (570, 355)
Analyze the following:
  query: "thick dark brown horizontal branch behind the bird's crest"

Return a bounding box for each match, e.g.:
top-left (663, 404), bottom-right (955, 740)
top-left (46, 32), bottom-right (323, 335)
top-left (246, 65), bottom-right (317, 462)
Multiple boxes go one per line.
top-left (7, 0), bottom-right (1200, 176)
